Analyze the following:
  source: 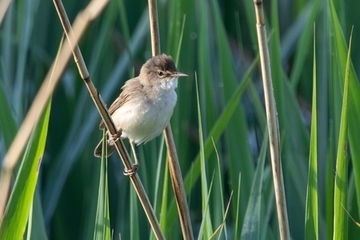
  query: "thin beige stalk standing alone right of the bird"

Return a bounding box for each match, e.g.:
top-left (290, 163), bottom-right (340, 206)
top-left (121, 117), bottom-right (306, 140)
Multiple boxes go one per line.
top-left (254, 0), bottom-right (290, 240)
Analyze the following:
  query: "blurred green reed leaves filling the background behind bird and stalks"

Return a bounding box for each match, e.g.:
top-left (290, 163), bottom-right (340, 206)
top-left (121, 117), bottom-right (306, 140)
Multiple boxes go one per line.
top-left (0, 0), bottom-right (360, 239)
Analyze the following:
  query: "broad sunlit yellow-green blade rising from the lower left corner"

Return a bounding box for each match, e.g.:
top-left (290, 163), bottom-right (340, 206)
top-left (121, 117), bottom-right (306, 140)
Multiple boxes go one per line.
top-left (0, 100), bottom-right (51, 239)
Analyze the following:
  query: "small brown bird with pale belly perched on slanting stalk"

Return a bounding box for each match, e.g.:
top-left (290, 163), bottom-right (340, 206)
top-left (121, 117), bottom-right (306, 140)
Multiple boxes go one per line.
top-left (94, 54), bottom-right (187, 165)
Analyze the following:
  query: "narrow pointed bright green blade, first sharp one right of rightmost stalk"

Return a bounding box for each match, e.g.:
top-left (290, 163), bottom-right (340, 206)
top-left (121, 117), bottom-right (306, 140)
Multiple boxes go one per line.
top-left (305, 27), bottom-right (319, 239)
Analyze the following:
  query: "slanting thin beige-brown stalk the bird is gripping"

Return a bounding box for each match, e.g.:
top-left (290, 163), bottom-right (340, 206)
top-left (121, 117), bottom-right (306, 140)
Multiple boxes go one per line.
top-left (54, 0), bottom-right (165, 239)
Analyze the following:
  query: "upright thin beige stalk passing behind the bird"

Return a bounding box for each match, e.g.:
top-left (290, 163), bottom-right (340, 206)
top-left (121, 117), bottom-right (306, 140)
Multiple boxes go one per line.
top-left (148, 0), bottom-right (194, 240)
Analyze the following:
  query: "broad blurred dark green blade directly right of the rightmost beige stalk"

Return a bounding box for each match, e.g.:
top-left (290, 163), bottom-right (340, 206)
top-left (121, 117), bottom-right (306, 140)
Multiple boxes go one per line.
top-left (269, 0), bottom-right (309, 235)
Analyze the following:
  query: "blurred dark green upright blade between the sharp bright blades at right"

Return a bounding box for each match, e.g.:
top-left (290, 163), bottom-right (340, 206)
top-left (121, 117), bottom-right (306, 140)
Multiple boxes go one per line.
top-left (316, 1), bottom-right (335, 239)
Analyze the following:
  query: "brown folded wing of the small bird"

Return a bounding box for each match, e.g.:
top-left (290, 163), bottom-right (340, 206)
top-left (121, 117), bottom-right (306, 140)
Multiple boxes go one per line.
top-left (99, 78), bottom-right (144, 129)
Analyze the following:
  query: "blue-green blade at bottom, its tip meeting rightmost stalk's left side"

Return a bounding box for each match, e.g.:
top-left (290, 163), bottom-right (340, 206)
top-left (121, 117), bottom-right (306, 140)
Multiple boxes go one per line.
top-left (241, 131), bottom-right (269, 239)
